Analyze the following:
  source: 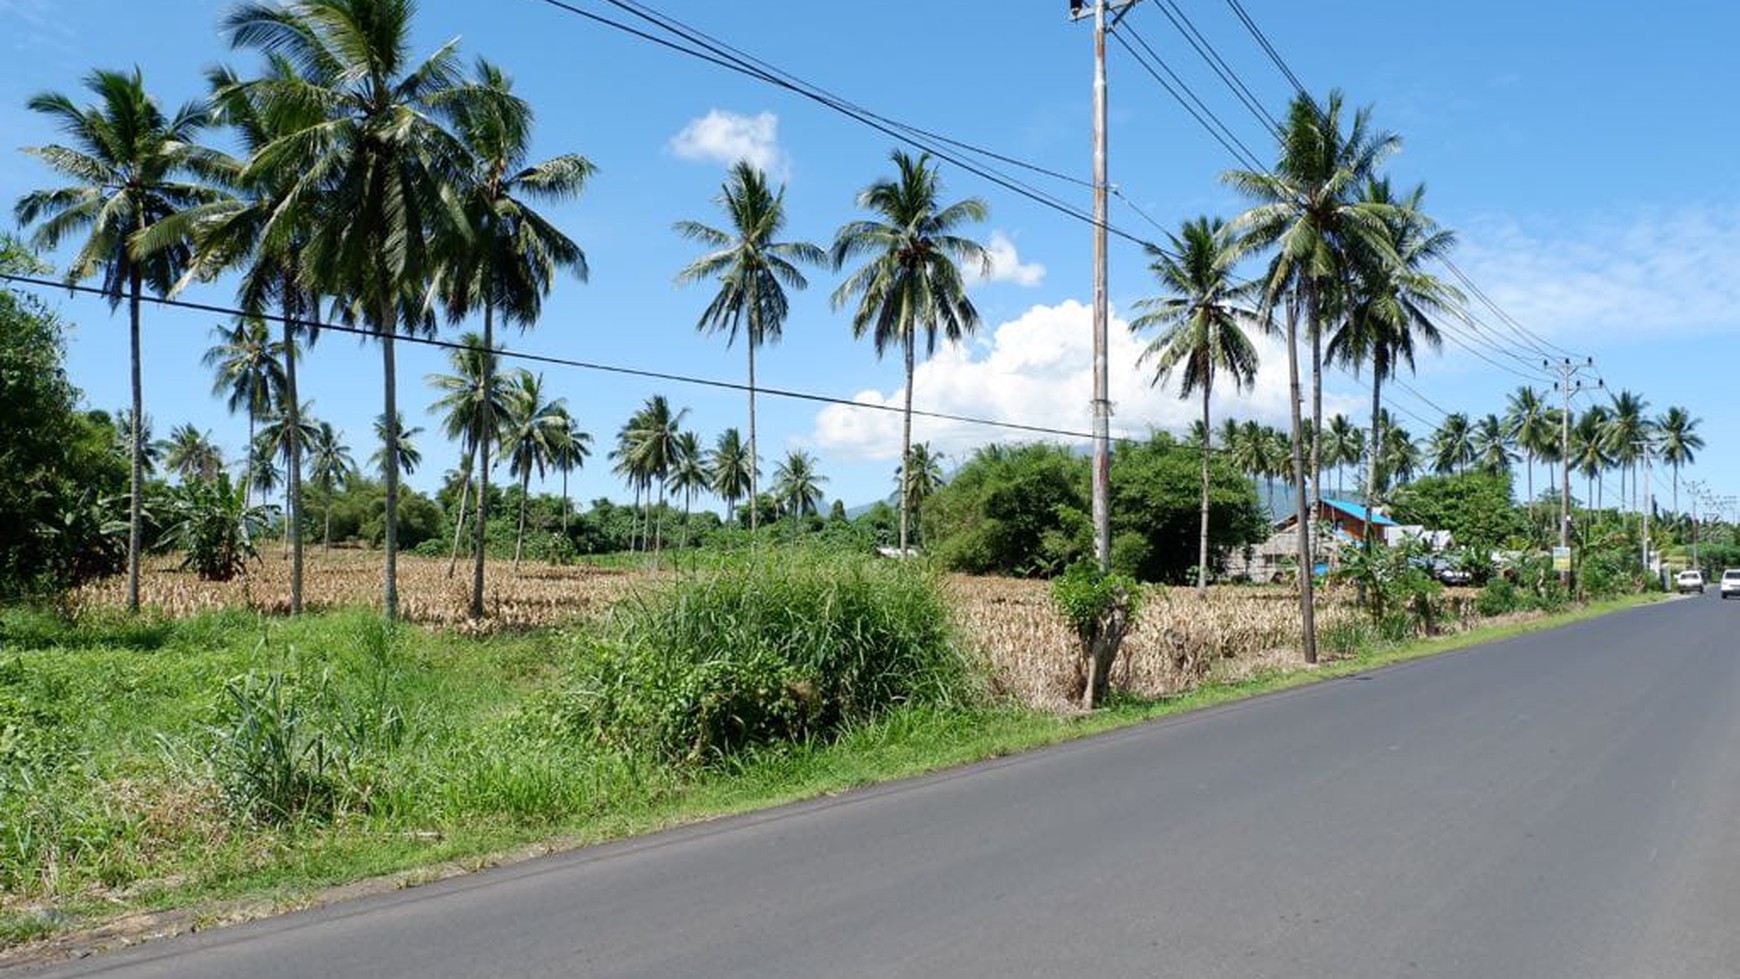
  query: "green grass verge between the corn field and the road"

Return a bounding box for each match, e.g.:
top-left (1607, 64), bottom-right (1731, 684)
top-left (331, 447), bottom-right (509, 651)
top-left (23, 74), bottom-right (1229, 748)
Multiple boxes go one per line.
top-left (0, 598), bottom-right (1648, 948)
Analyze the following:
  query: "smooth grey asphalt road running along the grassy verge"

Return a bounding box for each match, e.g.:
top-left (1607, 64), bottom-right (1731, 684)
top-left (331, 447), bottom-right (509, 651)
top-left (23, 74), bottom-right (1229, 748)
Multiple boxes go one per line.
top-left (27, 593), bottom-right (1740, 979)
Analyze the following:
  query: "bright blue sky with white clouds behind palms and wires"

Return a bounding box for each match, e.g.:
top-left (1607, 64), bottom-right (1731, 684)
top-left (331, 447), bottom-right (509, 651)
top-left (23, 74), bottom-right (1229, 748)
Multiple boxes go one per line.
top-left (0, 0), bottom-right (1740, 518)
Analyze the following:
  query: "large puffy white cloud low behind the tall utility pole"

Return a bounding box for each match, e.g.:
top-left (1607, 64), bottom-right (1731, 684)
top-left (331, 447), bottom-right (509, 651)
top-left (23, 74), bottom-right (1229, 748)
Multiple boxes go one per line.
top-left (809, 301), bottom-right (1359, 461)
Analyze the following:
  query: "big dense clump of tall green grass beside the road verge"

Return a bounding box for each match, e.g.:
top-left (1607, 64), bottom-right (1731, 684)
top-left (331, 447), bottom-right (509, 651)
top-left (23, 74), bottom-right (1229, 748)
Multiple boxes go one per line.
top-left (559, 556), bottom-right (974, 763)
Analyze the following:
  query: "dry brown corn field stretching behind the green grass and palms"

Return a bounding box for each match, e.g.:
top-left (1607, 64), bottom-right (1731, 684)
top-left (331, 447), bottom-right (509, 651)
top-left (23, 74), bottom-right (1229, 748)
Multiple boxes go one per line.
top-left (78, 551), bottom-right (1456, 706)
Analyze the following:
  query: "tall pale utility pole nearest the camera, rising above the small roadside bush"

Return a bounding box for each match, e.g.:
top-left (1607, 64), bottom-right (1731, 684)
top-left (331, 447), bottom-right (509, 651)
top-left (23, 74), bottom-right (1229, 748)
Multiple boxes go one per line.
top-left (1070, 0), bottom-right (1136, 570)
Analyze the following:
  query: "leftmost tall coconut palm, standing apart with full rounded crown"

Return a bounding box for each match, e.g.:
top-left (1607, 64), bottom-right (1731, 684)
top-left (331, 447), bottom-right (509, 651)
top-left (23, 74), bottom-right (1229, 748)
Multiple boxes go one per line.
top-left (14, 68), bottom-right (218, 612)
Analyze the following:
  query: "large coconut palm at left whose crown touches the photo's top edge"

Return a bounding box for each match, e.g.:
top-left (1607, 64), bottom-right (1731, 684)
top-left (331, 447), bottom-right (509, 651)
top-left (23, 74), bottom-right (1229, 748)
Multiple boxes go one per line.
top-left (223, 0), bottom-right (480, 621)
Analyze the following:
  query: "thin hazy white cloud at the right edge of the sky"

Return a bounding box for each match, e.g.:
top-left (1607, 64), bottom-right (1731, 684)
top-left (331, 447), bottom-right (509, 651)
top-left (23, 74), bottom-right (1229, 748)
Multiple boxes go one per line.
top-left (1458, 207), bottom-right (1740, 350)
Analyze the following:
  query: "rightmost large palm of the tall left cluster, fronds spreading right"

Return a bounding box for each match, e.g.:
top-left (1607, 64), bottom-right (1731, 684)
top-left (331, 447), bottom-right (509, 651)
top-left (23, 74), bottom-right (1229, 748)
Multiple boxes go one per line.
top-left (438, 59), bottom-right (595, 617)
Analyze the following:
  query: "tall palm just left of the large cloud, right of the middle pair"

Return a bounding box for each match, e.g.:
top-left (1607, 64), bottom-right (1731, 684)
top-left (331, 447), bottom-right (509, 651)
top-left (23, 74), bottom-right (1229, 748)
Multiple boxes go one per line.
top-left (833, 150), bottom-right (990, 555)
